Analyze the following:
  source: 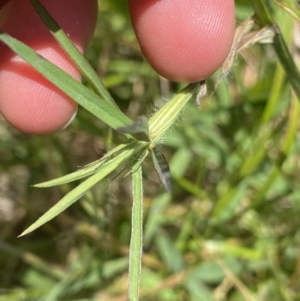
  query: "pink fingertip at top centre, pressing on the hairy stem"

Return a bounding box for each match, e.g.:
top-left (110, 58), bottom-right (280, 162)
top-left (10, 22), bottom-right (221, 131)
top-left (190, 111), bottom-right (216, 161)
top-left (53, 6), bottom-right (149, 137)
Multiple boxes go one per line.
top-left (128, 0), bottom-right (235, 82)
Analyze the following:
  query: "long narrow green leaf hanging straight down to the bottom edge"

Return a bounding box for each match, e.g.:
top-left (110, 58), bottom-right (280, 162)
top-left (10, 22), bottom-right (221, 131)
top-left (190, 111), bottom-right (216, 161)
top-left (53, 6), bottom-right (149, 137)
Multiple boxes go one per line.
top-left (128, 162), bottom-right (143, 301)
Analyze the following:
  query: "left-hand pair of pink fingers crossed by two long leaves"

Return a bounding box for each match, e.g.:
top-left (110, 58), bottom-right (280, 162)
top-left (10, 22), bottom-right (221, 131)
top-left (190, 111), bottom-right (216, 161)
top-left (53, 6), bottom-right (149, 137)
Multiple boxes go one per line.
top-left (0, 0), bottom-right (97, 134)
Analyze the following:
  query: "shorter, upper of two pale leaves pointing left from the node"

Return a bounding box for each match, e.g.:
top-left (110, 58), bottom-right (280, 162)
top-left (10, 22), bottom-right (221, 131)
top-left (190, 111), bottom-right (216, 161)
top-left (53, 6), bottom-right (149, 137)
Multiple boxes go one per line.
top-left (33, 143), bottom-right (127, 188)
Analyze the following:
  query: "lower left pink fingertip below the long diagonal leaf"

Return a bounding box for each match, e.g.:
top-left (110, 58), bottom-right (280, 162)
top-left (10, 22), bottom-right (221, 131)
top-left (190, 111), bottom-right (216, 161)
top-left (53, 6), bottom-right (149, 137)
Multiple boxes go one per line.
top-left (0, 53), bottom-right (78, 135)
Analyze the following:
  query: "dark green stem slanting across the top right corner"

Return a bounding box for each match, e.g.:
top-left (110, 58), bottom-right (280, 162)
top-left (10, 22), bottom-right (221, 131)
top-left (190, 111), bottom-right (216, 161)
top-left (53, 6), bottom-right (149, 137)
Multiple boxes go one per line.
top-left (250, 0), bottom-right (300, 101)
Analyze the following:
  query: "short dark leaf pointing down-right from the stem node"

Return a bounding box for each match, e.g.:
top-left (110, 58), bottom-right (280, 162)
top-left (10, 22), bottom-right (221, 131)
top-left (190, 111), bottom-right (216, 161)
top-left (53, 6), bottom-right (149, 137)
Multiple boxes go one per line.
top-left (152, 147), bottom-right (172, 194)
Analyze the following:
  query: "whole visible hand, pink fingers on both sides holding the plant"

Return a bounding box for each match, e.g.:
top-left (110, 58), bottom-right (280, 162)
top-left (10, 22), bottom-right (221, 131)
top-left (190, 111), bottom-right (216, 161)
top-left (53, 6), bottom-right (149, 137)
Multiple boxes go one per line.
top-left (0, 0), bottom-right (235, 134)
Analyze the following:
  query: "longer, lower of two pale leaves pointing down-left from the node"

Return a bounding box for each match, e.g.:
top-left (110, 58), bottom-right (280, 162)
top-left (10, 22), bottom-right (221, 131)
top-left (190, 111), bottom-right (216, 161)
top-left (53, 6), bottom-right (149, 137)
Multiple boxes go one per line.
top-left (19, 144), bottom-right (143, 237)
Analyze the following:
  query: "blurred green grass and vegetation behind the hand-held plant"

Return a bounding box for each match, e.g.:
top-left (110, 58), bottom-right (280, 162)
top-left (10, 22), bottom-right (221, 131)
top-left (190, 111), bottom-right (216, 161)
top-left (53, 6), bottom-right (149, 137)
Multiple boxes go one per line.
top-left (0, 0), bottom-right (300, 301)
